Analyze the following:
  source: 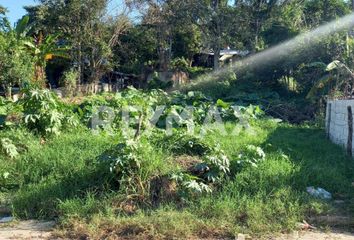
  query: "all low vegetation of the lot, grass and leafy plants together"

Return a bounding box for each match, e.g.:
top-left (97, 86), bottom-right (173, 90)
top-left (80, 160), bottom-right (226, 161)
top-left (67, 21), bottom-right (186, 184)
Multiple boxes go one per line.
top-left (0, 89), bottom-right (353, 238)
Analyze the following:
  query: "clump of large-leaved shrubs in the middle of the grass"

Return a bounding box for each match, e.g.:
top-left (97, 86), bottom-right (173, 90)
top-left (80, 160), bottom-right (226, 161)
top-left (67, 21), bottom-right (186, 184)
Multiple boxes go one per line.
top-left (102, 127), bottom-right (230, 199)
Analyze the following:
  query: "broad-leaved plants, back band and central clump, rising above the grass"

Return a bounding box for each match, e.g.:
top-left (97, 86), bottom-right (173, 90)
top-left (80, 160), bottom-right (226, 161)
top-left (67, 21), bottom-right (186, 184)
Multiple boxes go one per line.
top-left (1, 88), bottom-right (264, 212)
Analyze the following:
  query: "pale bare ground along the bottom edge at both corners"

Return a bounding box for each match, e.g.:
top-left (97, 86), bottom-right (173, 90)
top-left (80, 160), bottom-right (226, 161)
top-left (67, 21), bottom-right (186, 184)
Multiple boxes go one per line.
top-left (0, 206), bottom-right (354, 240)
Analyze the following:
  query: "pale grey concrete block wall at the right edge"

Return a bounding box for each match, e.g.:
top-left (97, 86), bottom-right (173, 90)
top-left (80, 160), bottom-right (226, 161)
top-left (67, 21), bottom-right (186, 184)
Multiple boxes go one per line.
top-left (326, 100), bottom-right (354, 152)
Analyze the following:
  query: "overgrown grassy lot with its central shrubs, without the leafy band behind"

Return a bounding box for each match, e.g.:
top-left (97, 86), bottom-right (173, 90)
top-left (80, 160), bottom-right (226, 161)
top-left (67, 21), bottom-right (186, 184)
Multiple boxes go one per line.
top-left (0, 89), bottom-right (354, 239)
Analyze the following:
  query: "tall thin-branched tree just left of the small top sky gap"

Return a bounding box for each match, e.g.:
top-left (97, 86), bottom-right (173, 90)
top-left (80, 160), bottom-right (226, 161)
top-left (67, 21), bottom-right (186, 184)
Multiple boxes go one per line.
top-left (27, 0), bottom-right (130, 85)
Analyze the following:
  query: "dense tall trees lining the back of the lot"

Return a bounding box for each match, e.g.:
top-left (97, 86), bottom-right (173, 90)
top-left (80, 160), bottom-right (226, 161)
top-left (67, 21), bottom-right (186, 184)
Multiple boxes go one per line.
top-left (0, 0), bottom-right (354, 104)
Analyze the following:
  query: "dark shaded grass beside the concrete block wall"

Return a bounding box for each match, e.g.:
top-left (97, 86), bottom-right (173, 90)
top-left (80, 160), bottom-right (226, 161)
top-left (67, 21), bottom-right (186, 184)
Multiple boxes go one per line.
top-left (264, 126), bottom-right (354, 198)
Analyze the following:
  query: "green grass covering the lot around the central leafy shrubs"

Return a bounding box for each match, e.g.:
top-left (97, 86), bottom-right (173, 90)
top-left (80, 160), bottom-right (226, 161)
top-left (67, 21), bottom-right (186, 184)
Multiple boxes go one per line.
top-left (0, 120), bottom-right (354, 239)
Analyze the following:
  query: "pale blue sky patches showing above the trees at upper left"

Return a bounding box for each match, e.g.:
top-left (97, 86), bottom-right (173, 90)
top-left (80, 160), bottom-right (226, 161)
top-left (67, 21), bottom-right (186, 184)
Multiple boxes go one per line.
top-left (0, 0), bottom-right (127, 24)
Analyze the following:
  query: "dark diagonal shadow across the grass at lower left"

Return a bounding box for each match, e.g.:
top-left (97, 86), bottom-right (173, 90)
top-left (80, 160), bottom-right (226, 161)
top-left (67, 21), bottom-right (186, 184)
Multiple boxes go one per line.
top-left (12, 148), bottom-right (117, 219)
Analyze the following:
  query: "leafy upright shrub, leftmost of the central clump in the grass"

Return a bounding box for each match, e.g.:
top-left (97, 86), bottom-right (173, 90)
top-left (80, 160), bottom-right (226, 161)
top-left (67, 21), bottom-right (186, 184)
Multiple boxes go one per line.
top-left (100, 132), bottom-right (170, 197)
